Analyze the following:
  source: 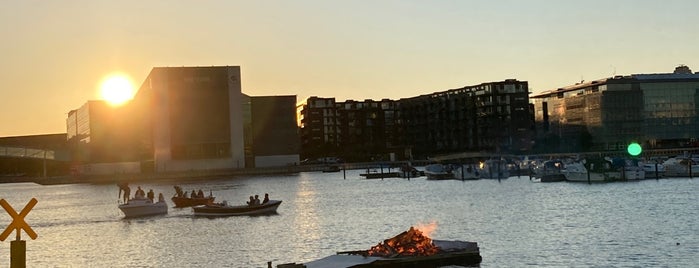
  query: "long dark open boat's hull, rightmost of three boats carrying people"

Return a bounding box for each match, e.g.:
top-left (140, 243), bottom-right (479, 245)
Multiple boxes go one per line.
top-left (192, 200), bottom-right (282, 216)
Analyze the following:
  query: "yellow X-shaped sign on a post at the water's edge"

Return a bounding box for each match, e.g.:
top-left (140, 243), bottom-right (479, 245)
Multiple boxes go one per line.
top-left (0, 198), bottom-right (39, 268)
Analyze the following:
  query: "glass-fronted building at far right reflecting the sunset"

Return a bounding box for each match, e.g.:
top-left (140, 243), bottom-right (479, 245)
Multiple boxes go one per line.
top-left (531, 66), bottom-right (699, 151)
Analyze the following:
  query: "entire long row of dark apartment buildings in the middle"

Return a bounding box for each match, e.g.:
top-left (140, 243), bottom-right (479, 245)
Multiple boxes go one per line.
top-left (300, 79), bottom-right (533, 160)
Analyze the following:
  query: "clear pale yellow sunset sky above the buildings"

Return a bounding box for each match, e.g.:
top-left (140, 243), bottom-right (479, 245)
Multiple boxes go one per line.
top-left (0, 0), bottom-right (699, 137)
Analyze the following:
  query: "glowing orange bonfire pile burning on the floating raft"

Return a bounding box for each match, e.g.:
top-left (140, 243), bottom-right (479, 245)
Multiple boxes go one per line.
top-left (367, 226), bottom-right (439, 257)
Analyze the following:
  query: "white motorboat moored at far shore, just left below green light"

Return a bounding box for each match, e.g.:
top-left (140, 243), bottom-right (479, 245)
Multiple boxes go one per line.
top-left (562, 161), bottom-right (621, 182)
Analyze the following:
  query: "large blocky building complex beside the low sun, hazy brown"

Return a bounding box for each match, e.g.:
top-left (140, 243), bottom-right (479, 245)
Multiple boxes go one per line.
top-left (66, 66), bottom-right (299, 174)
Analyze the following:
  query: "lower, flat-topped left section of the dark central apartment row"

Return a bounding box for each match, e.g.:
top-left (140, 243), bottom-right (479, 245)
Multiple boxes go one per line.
top-left (299, 96), bottom-right (400, 161)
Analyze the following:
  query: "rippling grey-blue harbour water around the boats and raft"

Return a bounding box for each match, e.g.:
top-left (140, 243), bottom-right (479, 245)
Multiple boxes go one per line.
top-left (0, 170), bottom-right (699, 267)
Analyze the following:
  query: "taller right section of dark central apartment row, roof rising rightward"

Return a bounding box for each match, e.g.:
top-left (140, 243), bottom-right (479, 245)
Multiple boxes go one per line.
top-left (399, 79), bottom-right (533, 158)
